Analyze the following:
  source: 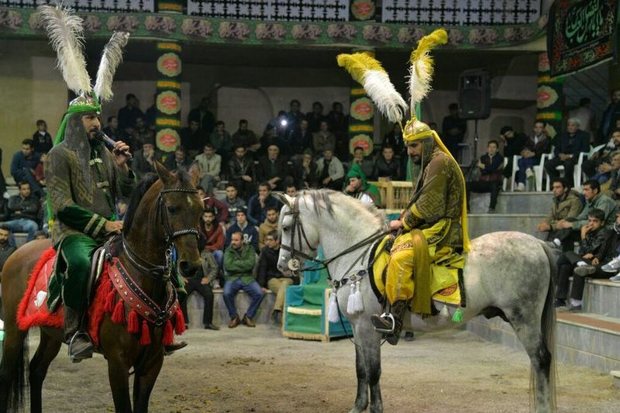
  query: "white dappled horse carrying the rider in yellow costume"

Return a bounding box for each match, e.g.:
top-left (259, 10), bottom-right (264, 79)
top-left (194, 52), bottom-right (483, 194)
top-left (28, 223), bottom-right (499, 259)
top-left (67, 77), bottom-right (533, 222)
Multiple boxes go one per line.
top-left (278, 190), bottom-right (556, 413)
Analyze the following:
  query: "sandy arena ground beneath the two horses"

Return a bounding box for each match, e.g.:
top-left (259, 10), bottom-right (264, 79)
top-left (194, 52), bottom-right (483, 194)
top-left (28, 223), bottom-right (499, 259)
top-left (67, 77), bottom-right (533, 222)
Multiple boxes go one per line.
top-left (17, 325), bottom-right (620, 413)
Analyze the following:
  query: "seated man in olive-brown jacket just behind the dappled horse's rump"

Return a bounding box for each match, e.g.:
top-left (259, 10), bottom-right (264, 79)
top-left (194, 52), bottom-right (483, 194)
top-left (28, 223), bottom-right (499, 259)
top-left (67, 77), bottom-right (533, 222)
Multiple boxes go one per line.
top-left (537, 178), bottom-right (583, 245)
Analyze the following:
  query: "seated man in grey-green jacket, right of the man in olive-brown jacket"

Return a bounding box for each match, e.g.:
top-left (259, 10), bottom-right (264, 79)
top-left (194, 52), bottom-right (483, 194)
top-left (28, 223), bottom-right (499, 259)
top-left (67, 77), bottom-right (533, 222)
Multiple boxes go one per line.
top-left (555, 179), bottom-right (616, 237)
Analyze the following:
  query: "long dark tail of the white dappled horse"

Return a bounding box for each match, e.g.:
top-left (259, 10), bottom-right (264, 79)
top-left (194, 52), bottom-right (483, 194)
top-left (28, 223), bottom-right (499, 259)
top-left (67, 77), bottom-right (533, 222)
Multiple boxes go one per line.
top-left (540, 242), bottom-right (559, 412)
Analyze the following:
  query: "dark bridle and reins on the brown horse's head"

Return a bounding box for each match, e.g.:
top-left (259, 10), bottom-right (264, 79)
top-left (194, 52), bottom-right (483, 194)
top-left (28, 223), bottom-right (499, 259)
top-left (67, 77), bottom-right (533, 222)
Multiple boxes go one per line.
top-left (121, 188), bottom-right (199, 281)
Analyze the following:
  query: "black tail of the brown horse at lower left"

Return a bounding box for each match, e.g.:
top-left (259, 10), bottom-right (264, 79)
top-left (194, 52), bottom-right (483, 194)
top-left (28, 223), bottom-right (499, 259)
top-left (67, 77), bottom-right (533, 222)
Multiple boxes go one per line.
top-left (0, 325), bottom-right (30, 413)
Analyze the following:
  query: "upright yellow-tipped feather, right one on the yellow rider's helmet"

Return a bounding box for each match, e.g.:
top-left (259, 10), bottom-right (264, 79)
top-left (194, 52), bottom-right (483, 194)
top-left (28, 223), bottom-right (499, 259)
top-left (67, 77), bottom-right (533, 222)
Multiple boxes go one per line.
top-left (409, 29), bottom-right (448, 108)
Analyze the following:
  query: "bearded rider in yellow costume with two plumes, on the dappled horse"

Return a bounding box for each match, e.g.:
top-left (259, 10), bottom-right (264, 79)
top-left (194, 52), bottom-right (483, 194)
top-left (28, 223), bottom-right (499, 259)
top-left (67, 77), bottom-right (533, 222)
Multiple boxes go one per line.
top-left (338, 29), bottom-right (469, 344)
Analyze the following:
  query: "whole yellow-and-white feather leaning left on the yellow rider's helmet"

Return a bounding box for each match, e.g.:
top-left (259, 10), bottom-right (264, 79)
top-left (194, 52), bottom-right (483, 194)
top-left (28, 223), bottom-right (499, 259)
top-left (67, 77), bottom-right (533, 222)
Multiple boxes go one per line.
top-left (337, 53), bottom-right (407, 122)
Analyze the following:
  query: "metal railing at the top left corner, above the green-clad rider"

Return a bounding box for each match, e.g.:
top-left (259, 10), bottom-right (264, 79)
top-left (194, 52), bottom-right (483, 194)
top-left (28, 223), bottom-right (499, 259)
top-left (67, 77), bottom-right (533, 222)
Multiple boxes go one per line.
top-left (0, 0), bottom-right (155, 13)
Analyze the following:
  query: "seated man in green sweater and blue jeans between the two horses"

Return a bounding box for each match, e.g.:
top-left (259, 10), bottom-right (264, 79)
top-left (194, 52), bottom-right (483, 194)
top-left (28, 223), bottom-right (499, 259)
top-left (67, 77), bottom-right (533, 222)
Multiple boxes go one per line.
top-left (224, 230), bottom-right (264, 328)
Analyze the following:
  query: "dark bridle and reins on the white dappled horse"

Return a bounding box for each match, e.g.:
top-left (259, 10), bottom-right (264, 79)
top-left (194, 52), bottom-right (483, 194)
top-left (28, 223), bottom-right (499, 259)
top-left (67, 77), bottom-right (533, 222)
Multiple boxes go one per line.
top-left (280, 197), bottom-right (390, 281)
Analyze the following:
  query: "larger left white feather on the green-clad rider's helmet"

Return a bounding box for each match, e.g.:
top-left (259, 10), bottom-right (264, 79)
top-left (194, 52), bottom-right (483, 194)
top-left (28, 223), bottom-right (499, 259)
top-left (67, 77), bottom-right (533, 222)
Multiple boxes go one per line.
top-left (39, 6), bottom-right (91, 95)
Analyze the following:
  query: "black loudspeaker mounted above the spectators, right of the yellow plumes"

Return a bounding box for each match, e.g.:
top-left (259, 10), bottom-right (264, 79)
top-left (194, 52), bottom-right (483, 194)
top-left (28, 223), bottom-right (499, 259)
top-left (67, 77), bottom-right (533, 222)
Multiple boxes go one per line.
top-left (459, 69), bottom-right (491, 119)
